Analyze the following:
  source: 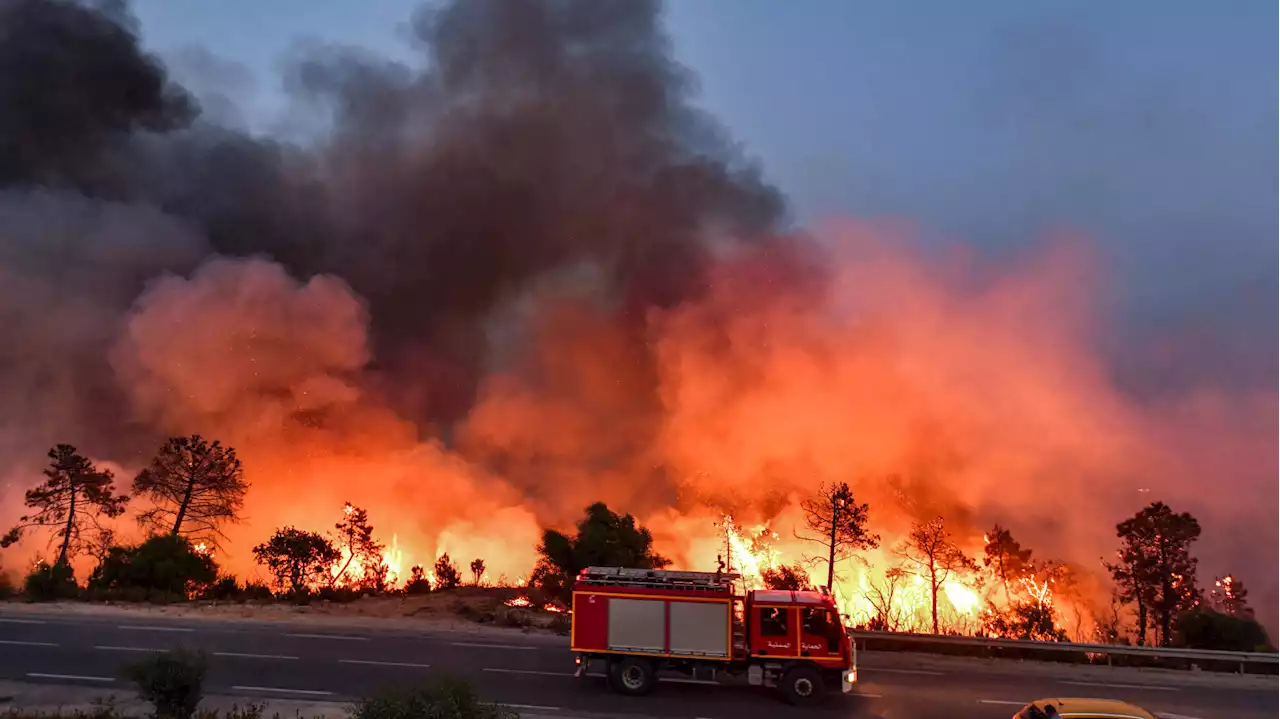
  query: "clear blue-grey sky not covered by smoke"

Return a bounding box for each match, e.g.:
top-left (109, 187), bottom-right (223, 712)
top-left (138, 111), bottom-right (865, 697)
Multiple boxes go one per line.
top-left (134, 0), bottom-right (1280, 386)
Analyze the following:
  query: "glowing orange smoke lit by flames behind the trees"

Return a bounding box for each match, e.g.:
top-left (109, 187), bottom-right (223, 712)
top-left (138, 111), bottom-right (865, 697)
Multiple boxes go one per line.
top-left (2, 218), bottom-right (1280, 619)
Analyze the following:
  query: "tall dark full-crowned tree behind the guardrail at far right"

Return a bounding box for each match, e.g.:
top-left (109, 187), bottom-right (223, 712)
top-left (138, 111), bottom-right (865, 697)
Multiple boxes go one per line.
top-left (1107, 502), bottom-right (1201, 646)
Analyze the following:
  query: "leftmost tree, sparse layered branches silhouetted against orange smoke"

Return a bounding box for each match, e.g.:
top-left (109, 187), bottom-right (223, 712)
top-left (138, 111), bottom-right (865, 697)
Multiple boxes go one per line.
top-left (0, 444), bottom-right (129, 567)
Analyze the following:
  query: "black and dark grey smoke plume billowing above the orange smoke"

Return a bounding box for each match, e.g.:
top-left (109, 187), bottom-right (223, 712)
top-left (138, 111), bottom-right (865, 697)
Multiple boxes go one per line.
top-left (0, 0), bottom-right (783, 421)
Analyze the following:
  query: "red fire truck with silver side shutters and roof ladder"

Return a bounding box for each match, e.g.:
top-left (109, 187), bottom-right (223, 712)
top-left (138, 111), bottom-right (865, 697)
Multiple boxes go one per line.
top-left (571, 567), bottom-right (858, 705)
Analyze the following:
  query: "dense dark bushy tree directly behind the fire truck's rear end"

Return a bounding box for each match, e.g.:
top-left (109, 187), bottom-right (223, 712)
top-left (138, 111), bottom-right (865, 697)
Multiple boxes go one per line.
top-left (530, 502), bottom-right (671, 600)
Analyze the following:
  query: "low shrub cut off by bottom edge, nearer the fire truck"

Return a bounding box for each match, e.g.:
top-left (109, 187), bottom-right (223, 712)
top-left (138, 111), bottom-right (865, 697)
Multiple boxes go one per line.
top-left (351, 674), bottom-right (518, 719)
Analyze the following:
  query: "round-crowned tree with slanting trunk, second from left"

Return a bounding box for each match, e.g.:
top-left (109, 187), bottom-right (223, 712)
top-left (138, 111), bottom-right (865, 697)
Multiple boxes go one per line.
top-left (133, 435), bottom-right (248, 542)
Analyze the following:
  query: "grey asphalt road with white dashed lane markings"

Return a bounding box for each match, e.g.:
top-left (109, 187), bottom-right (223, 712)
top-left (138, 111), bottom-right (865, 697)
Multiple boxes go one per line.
top-left (0, 613), bottom-right (1280, 719)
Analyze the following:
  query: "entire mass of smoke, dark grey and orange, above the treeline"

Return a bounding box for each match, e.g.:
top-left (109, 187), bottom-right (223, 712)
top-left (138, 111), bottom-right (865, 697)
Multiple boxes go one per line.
top-left (0, 0), bottom-right (1280, 626)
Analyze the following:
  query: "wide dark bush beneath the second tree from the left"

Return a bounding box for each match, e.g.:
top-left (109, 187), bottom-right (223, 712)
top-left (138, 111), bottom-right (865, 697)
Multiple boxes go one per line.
top-left (88, 535), bottom-right (218, 603)
